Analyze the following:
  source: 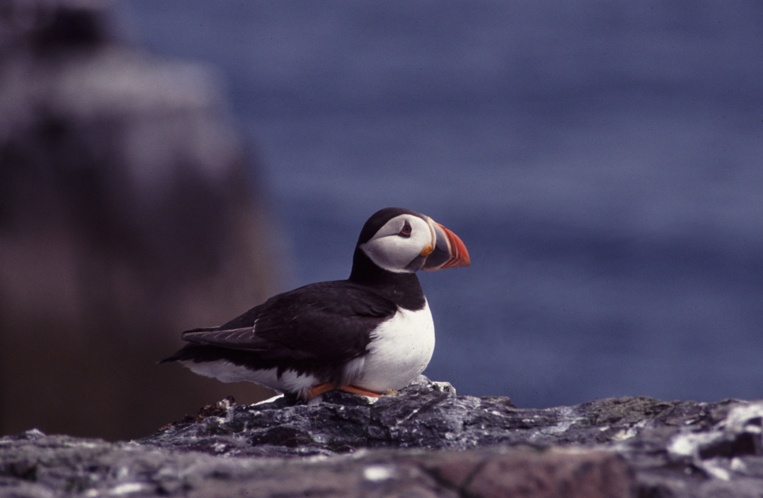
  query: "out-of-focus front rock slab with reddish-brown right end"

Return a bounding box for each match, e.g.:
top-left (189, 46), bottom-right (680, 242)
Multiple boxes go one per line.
top-left (0, 432), bottom-right (635, 498)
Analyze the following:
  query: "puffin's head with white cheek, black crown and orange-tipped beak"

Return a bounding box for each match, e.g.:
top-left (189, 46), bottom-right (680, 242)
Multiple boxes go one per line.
top-left (358, 208), bottom-right (469, 273)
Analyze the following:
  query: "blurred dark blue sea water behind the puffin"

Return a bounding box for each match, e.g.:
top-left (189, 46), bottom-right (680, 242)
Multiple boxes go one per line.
top-left (124, 0), bottom-right (763, 406)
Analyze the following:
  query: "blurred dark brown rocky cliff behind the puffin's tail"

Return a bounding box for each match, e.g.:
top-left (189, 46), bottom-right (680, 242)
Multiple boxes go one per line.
top-left (0, 0), bottom-right (278, 438)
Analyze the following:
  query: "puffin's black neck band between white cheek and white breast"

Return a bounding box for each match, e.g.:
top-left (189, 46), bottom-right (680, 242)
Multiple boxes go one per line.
top-left (349, 248), bottom-right (426, 310)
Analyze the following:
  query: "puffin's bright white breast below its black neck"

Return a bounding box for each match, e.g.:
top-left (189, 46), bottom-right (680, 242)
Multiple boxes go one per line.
top-left (354, 302), bottom-right (435, 392)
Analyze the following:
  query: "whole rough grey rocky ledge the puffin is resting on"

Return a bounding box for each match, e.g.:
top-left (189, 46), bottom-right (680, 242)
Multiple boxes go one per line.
top-left (0, 377), bottom-right (763, 498)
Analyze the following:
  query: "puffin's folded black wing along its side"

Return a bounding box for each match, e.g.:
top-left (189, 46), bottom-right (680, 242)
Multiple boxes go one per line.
top-left (176, 281), bottom-right (397, 363)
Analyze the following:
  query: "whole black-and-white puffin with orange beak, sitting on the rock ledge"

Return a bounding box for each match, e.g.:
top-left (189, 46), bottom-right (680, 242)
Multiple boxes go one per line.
top-left (160, 207), bottom-right (470, 400)
